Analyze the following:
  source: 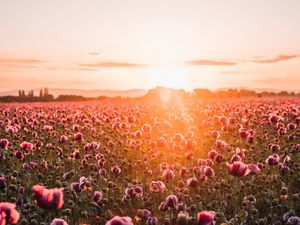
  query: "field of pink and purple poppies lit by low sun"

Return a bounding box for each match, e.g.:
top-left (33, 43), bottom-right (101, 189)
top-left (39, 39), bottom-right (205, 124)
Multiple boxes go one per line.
top-left (0, 98), bottom-right (300, 225)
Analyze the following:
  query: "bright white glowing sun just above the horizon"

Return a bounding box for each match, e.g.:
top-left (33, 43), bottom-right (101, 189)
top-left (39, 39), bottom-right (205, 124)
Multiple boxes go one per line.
top-left (148, 66), bottom-right (187, 89)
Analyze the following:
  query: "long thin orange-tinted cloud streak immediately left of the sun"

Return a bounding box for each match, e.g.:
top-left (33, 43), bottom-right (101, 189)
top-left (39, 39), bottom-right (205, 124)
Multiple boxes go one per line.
top-left (79, 61), bottom-right (147, 68)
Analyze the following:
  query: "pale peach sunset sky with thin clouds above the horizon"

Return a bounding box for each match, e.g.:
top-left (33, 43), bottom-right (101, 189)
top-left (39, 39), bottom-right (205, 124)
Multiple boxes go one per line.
top-left (0, 0), bottom-right (300, 91)
